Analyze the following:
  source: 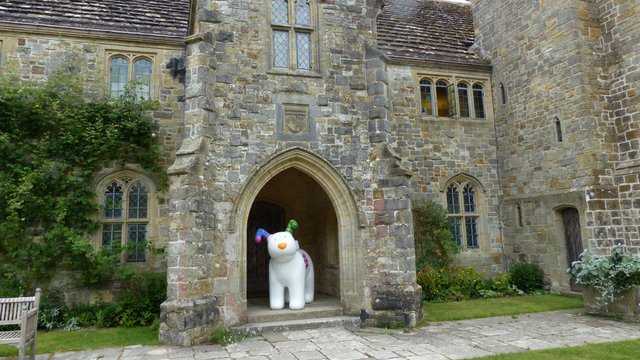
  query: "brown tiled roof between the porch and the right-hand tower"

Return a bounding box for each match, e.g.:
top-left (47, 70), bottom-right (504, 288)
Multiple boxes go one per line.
top-left (377, 0), bottom-right (485, 65)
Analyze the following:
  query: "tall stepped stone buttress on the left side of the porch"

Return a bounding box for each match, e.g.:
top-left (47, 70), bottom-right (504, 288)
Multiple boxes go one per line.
top-left (160, 2), bottom-right (221, 346)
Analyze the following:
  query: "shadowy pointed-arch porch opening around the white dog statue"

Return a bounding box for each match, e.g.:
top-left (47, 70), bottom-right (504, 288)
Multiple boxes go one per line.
top-left (246, 168), bottom-right (340, 302)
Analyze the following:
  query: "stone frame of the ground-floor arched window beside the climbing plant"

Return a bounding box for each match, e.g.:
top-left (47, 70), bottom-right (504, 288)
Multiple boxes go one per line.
top-left (93, 169), bottom-right (158, 266)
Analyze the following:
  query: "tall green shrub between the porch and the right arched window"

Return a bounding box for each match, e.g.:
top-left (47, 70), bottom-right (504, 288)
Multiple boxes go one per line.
top-left (412, 200), bottom-right (460, 270)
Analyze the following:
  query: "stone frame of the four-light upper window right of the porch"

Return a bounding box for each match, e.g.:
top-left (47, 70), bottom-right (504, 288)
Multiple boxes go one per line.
top-left (416, 72), bottom-right (493, 121)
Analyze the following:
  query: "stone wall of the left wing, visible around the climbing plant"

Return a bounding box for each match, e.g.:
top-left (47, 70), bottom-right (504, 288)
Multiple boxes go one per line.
top-left (0, 29), bottom-right (184, 272)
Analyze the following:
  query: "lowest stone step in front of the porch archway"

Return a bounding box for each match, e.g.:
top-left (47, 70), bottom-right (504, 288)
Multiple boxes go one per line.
top-left (231, 316), bottom-right (360, 336)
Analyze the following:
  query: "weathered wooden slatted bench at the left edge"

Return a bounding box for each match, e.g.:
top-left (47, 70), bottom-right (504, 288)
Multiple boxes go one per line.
top-left (0, 289), bottom-right (40, 360)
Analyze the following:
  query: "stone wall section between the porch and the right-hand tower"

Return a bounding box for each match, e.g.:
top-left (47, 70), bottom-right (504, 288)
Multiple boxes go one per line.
top-left (389, 65), bottom-right (504, 274)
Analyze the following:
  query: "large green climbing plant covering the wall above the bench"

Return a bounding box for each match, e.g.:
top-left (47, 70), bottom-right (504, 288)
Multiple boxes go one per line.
top-left (0, 76), bottom-right (164, 296)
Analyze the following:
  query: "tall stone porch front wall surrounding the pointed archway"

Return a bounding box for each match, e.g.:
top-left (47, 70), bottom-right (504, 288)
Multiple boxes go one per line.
top-left (161, 0), bottom-right (420, 344)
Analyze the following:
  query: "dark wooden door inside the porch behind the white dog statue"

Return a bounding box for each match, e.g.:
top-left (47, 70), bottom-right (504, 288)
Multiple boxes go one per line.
top-left (247, 201), bottom-right (286, 298)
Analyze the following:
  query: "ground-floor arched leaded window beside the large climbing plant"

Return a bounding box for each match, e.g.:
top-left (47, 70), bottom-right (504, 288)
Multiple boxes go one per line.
top-left (99, 176), bottom-right (150, 262)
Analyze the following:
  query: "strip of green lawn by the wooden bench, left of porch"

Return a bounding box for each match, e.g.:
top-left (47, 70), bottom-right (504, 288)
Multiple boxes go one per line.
top-left (0, 327), bottom-right (160, 356)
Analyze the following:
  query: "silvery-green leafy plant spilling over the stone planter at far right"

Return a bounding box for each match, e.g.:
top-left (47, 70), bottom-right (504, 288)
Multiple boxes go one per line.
top-left (567, 245), bottom-right (640, 308)
